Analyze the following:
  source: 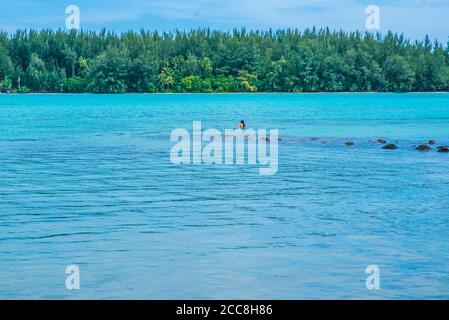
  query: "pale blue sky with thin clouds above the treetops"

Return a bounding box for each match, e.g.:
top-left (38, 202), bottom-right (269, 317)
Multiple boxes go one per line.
top-left (0, 0), bottom-right (449, 42)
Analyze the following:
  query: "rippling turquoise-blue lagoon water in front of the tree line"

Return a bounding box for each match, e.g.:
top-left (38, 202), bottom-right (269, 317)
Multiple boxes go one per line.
top-left (0, 94), bottom-right (449, 299)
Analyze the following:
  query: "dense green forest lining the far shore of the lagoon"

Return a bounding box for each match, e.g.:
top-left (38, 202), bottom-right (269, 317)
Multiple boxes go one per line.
top-left (0, 28), bottom-right (449, 93)
